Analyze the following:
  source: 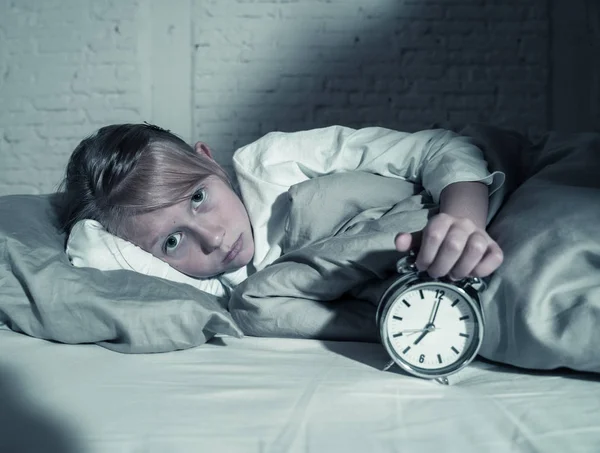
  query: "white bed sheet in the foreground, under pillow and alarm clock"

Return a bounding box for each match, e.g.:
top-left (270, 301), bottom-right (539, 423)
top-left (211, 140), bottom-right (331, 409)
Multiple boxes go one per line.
top-left (0, 330), bottom-right (600, 453)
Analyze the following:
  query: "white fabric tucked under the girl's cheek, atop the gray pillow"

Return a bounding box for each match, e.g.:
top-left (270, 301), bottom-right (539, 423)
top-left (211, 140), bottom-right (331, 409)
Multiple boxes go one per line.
top-left (66, 219), bottom-right (227, 297)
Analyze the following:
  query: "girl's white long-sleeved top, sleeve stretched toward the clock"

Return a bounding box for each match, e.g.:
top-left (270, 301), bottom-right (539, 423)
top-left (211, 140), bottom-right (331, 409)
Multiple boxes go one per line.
top-left (233, 126), bottom-right (504, 268)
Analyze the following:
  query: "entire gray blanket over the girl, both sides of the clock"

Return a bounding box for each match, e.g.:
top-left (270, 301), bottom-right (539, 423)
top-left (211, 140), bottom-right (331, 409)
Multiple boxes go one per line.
top-left (229, 126), bottom-right (600, 372)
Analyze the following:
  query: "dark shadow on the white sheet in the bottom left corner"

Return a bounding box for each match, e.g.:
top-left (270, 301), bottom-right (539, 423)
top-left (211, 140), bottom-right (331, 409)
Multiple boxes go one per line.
top-left (0, 369), bottom-right (83, 453)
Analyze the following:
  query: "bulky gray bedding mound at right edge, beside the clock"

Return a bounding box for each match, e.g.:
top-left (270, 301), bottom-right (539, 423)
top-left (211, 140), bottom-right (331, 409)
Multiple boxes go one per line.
top-left (481, 134), bottom-right (600, 372)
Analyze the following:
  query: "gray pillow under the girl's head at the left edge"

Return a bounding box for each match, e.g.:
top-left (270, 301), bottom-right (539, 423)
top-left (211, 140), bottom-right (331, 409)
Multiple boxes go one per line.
top-left (0, 194), bottom-right (241, 353)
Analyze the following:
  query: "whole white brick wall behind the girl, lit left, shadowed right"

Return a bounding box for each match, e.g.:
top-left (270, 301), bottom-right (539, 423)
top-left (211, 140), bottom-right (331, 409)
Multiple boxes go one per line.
top-left (0, 0), bottom-right (600, 195)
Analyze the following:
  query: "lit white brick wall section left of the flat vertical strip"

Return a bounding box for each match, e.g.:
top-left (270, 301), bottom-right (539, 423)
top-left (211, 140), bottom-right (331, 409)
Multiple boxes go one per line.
top-left (0, 0), bottom-right (143, 195)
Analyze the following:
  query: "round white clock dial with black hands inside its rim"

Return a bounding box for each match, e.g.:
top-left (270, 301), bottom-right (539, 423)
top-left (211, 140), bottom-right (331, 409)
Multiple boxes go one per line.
top-left (382, 282), bottom-right (482, 377)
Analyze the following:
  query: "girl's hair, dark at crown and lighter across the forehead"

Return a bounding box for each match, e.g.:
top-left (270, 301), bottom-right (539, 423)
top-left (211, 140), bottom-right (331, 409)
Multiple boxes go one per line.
top-left (61, 123), bottom-right (231, 238)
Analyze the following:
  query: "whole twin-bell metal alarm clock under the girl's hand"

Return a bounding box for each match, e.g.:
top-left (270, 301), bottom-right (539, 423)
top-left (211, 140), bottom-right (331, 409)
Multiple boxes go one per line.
top-left (376, 252), bottom-right (485, 385)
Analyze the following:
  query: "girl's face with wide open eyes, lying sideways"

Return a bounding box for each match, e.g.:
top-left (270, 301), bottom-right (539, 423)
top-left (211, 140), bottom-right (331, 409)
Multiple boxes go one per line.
top-left (128, 144), bottom-right (254, 278)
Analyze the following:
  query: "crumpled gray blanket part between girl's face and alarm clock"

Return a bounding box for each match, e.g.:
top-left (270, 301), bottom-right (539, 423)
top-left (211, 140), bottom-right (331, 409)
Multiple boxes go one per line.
top-left (229, 172), bottom-right (437, 341)
